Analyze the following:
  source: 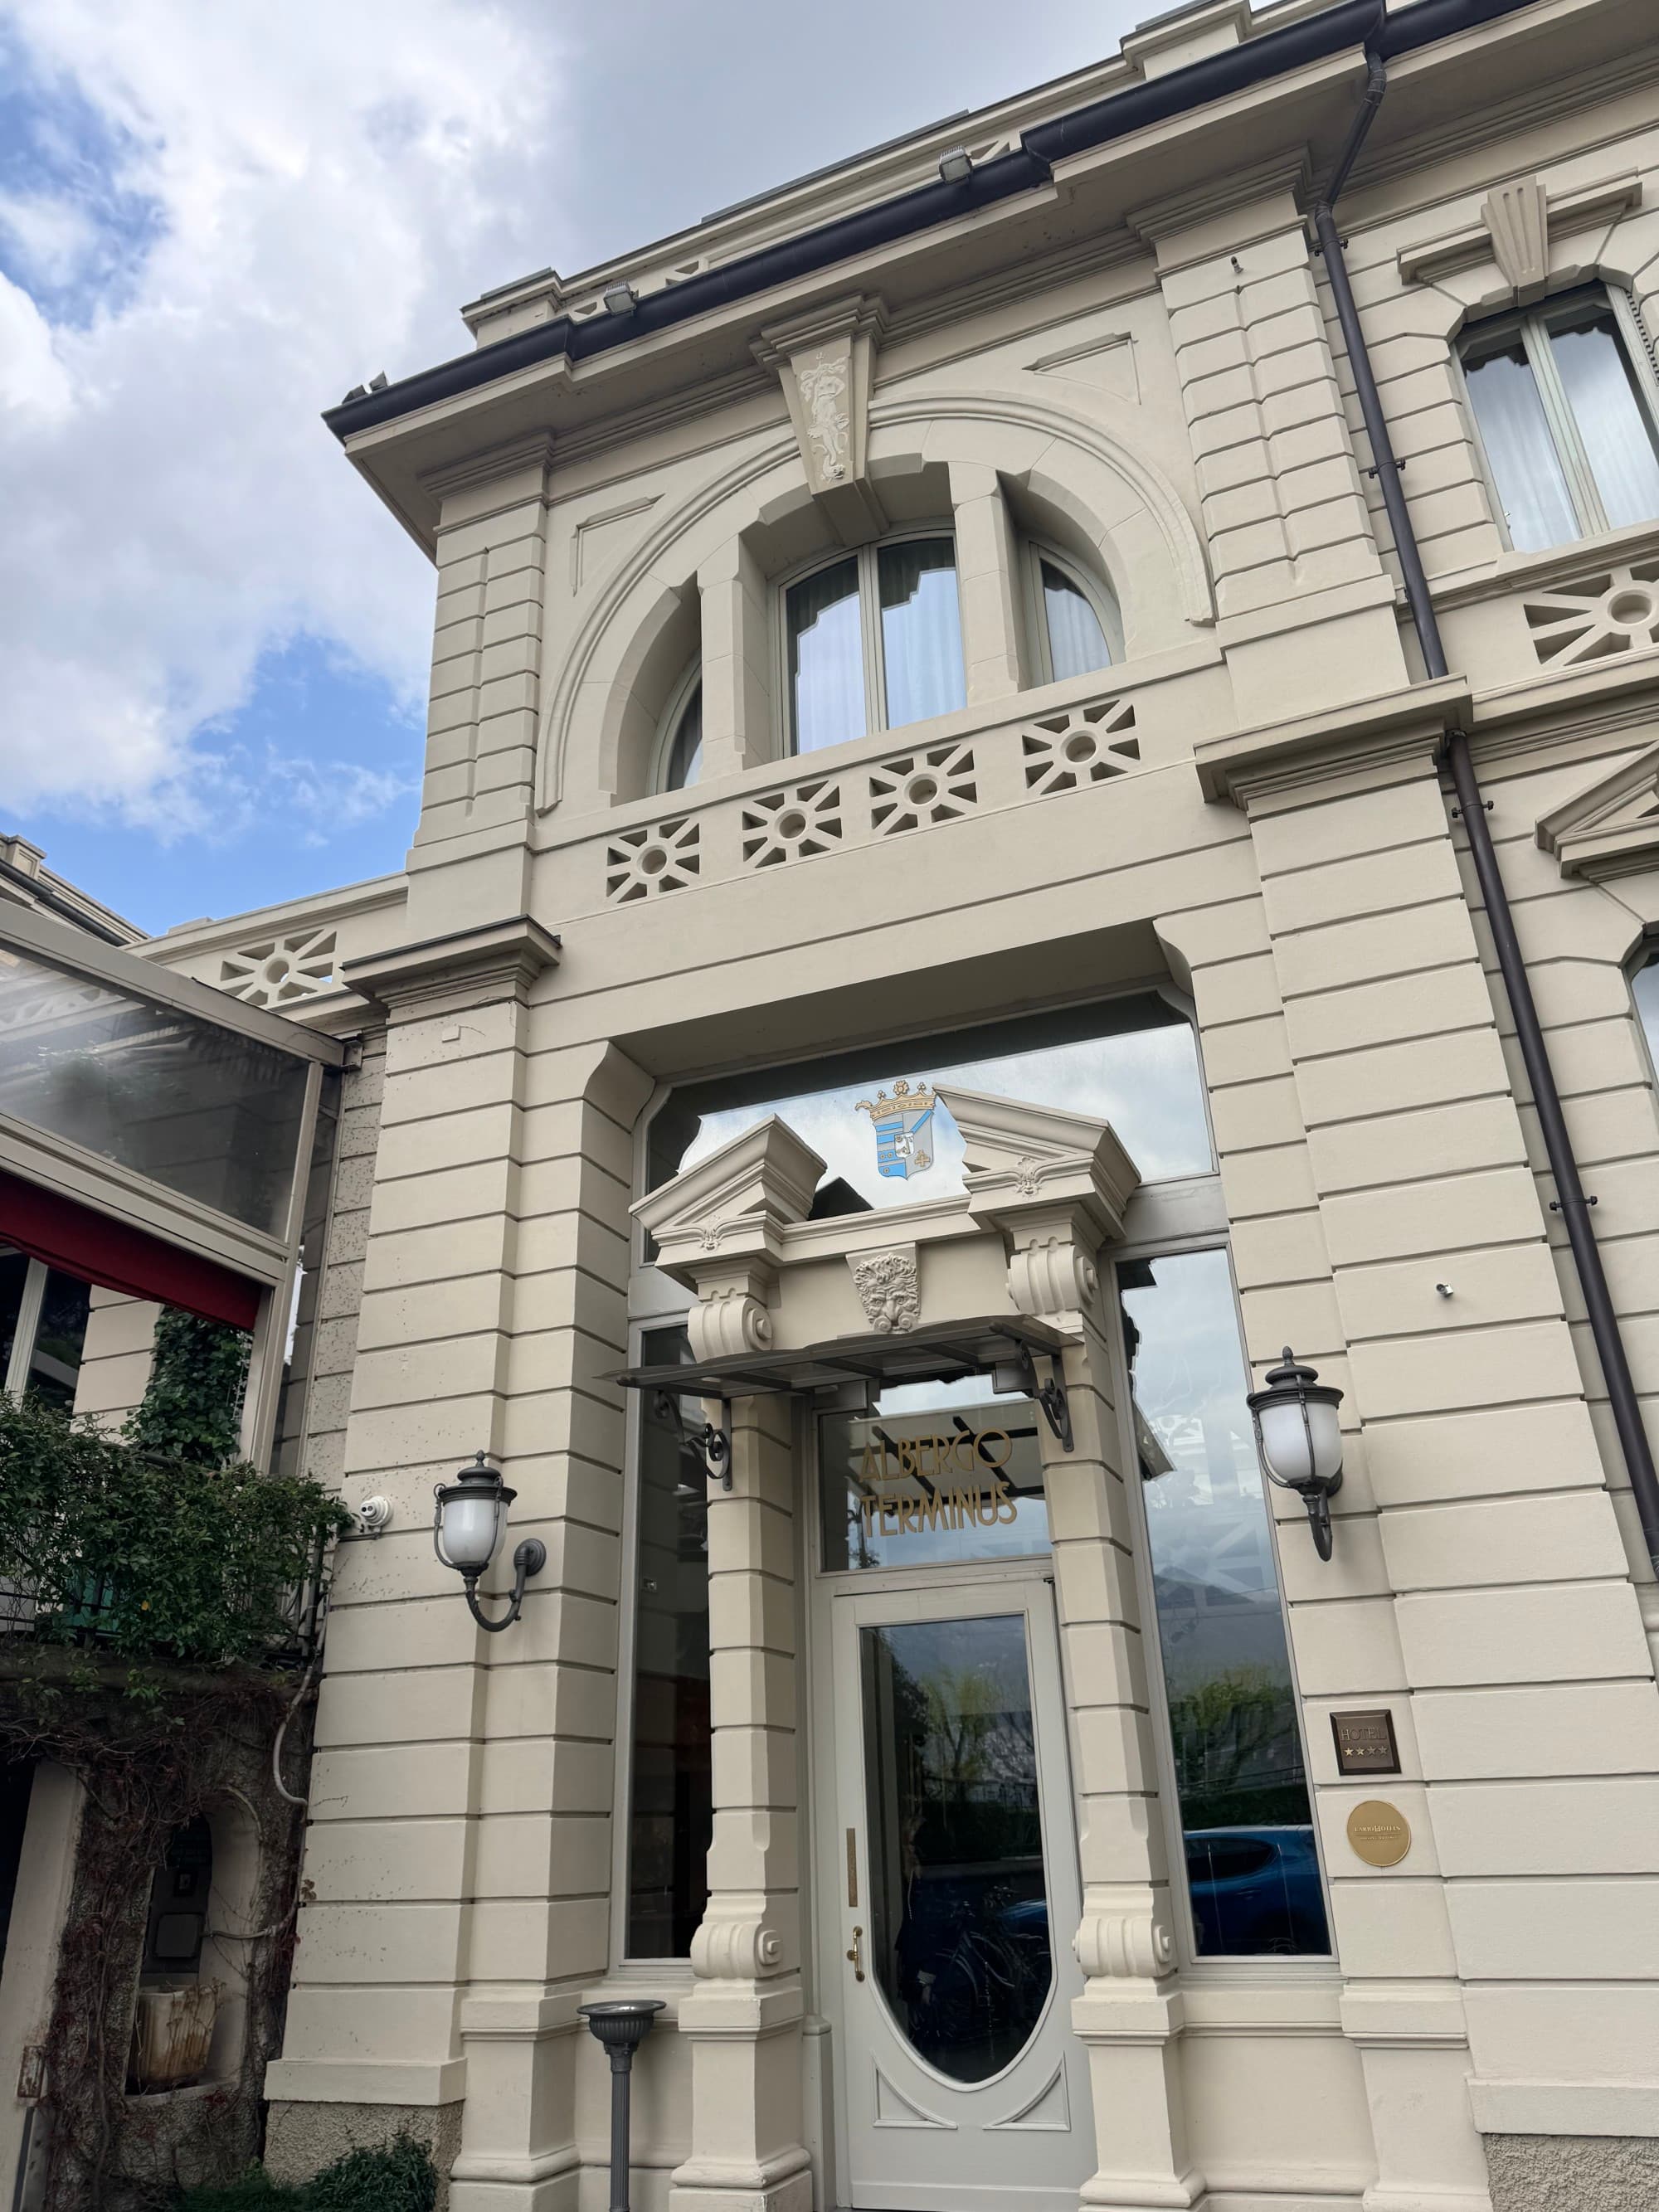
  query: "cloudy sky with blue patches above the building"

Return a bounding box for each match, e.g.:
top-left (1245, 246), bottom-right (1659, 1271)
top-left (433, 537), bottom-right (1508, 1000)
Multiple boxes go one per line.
top-left (0, 0), bottom-right (1155, 929)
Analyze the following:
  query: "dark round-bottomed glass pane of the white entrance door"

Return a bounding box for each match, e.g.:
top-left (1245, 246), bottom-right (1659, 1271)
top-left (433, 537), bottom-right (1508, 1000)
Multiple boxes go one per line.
top-left (859, 1615), bottom-right (1053, 2082)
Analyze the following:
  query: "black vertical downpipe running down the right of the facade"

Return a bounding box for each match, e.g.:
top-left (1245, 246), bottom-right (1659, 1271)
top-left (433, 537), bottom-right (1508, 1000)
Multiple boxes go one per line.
top-left (1314, 22), bottom-right (1659, 1568)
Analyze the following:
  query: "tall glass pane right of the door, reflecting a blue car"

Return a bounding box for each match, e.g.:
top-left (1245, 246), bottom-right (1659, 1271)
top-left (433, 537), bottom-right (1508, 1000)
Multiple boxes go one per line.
top-left (1117, 1252), bottom-right (1330, 1957)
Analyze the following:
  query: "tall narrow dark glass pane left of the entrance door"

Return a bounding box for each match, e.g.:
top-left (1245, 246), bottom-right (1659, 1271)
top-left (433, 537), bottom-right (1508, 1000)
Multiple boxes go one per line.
top-left (628, 1327), bottom-right (714, 1957)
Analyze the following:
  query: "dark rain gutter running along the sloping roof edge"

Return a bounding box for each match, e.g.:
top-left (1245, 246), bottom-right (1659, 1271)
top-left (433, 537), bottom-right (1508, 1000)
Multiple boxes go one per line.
top-left (323, 0), bottom-right (1533, 440)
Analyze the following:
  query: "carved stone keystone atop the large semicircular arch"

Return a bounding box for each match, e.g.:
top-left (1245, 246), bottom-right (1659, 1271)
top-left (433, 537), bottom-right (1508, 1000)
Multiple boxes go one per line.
top-left (754, 292), bottom-right (887, 544)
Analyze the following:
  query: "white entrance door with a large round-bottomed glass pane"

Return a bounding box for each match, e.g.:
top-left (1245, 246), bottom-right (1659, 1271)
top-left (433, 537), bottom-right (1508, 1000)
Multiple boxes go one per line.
top-left (825, 1573), bottom-right (1092, 2212)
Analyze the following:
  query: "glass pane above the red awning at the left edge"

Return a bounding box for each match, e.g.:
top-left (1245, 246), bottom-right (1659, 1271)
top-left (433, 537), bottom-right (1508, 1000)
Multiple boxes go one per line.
top-left (0, 945), bottom-right (308, 1234)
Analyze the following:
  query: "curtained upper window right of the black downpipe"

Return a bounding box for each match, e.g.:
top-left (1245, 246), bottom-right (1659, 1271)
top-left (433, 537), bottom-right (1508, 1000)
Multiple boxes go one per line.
top-left (1460, 288), bottom-right (1659, 551)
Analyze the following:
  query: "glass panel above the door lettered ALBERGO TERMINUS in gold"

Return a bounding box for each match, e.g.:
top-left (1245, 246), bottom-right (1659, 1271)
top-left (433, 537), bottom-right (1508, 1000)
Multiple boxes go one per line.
top-left (819, 1378), bottom-right (1048, 1573)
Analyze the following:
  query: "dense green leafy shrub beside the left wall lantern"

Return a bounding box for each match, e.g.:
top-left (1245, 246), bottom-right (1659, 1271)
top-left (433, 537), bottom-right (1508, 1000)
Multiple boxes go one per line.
top-left (0, 1392), bottom-right (352, 1665)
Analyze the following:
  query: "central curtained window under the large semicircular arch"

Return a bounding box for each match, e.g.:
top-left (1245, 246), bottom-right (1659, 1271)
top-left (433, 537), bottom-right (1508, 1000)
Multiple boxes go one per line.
top-left (783, 535), bottom-right (966, 752)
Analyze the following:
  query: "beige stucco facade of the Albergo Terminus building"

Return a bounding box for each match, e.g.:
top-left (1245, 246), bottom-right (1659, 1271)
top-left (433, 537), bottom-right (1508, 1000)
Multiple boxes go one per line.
top-left (133, 0), bottom-right (1659, 2212)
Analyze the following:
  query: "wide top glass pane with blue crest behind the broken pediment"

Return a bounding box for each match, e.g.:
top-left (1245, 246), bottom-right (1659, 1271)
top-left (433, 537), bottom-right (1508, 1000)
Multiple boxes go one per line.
top-left (650, 995), bottom-right (1214, 1213)
